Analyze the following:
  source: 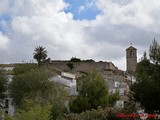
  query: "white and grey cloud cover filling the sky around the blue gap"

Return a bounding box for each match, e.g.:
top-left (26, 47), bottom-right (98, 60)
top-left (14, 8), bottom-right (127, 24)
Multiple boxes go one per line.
top-left (0, 0), bottom-right (160, 69)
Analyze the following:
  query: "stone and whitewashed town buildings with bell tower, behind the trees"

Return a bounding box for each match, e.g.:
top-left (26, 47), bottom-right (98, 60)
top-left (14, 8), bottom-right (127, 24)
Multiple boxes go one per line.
top-left (0, 46), bottom-right (137, 115)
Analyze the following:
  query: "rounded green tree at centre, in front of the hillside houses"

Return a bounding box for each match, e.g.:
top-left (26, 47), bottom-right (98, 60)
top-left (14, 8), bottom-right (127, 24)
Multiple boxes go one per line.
top-left (70, 71), bottom-right (117, 113)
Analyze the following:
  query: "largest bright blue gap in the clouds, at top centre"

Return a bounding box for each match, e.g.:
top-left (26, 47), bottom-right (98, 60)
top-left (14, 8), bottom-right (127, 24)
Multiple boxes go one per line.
top-left (65, 0), bottom-right (101, 20)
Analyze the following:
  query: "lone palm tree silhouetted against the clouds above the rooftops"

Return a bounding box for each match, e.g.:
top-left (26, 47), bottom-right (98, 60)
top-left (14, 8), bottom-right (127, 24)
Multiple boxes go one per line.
top-left (33, 46), bottom-right (47, 65)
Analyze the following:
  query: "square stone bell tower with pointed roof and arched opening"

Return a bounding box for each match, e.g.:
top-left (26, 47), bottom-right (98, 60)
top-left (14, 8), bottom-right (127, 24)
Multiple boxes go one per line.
top-left (126, 45), bottom-right (137, 74)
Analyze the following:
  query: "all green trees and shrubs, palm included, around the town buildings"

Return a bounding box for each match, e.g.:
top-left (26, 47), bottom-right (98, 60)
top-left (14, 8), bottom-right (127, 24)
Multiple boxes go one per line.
top-left (4, 40), bottom-right (160, 120)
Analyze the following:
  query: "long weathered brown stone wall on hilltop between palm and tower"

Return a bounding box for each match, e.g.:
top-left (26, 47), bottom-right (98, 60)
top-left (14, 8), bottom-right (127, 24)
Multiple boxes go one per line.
top-left (45, 61), bottom-right (124, 81)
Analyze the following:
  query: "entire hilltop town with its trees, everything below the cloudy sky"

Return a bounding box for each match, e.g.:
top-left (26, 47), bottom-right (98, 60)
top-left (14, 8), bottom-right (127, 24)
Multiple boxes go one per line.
top-left (0, 40), bottom-right (160, 120)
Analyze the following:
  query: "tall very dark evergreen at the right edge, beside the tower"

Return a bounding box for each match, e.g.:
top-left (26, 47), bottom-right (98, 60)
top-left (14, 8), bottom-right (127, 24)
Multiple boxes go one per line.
top-left (131, 41), bottom-right (160, 112)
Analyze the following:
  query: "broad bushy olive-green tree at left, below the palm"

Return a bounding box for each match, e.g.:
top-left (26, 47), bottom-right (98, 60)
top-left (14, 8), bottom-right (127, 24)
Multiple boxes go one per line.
top-left (10, 64), bottom-right (68, 119)
